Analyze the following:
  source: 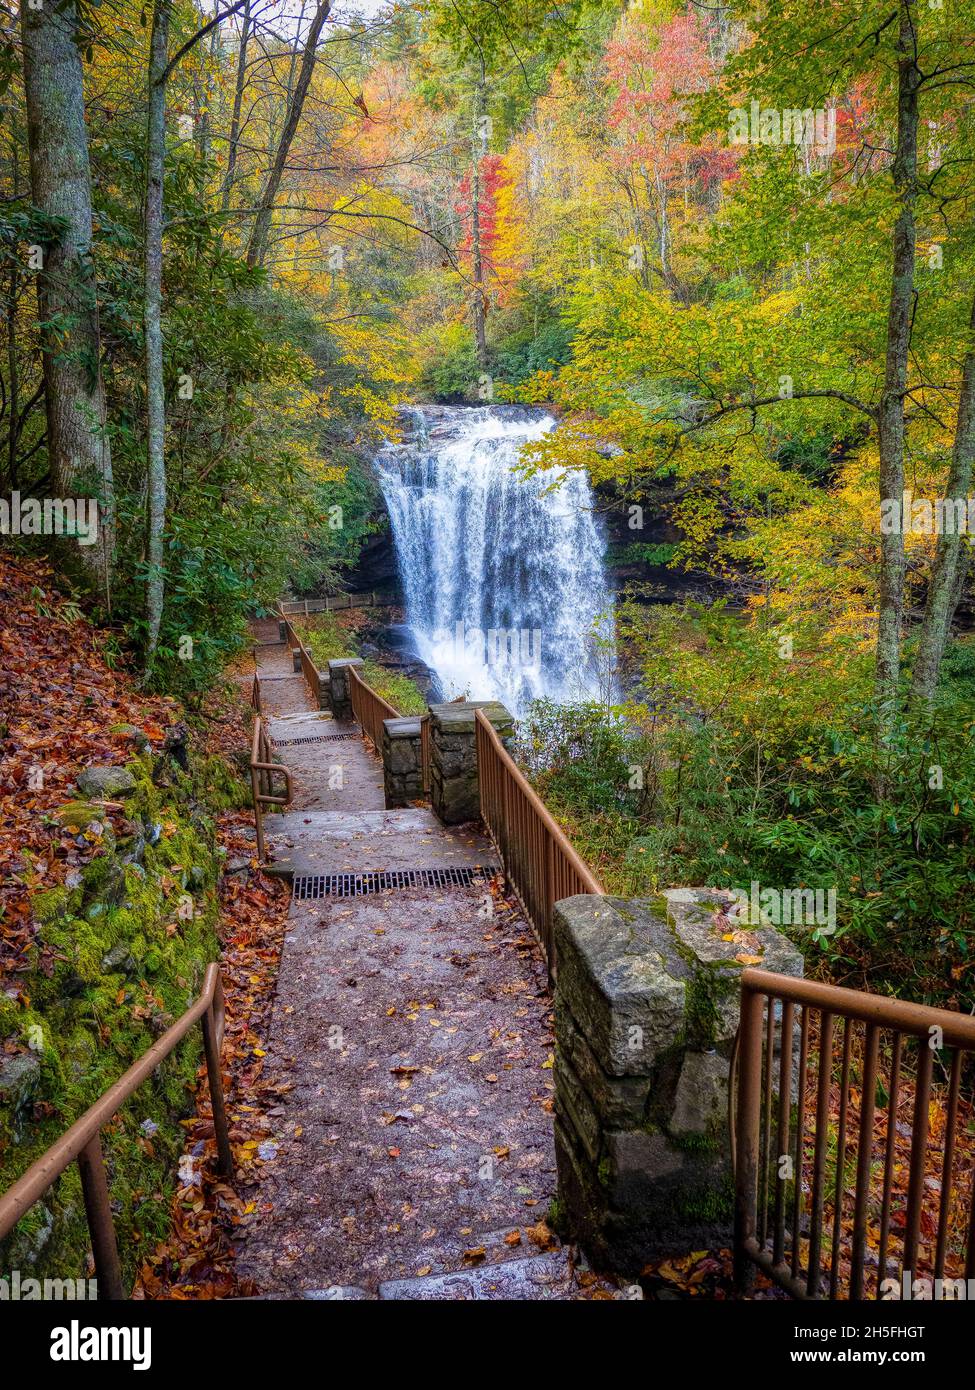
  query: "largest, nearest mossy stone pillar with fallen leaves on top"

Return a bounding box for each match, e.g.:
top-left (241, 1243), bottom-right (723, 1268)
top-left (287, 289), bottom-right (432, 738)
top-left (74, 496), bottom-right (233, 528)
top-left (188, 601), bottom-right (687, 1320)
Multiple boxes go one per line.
top-left (555, 888), bottom-right (803, 1275)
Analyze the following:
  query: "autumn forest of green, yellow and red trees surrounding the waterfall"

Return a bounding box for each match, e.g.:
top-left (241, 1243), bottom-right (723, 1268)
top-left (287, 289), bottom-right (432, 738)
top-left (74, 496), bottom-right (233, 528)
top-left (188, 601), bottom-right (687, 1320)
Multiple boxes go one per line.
top-left (0, 0), bottom-right (975, 994)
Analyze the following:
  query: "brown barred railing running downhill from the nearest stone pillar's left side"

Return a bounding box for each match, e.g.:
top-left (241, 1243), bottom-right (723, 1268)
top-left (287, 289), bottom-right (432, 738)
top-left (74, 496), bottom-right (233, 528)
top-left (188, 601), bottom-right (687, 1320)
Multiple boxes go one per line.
top-left (474, 709), bottom-right (604, 976)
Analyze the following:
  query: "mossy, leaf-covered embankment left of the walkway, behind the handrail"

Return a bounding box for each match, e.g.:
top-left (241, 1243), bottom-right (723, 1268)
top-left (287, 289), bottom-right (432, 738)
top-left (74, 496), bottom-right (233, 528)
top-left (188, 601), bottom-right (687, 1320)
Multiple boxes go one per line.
top-left (0, 550), bottom-right (246, 1280)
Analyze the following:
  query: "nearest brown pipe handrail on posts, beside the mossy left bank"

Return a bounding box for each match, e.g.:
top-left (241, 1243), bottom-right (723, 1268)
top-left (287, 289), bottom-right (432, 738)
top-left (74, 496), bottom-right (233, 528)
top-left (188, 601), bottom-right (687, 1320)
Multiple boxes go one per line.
top-left (0, 963), bottom-right (234, 1300)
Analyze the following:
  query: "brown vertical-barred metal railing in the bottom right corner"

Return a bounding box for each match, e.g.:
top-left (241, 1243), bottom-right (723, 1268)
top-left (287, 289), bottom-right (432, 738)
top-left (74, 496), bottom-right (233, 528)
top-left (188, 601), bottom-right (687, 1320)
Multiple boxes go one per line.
top-left (732, 969), bottom-right (975, 1300)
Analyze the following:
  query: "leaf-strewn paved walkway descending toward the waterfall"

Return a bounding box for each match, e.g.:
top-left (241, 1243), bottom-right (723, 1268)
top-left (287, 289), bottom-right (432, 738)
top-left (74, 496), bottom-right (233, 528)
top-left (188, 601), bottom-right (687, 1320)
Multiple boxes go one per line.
top-left (233, 624), bottom-right (608, 1300)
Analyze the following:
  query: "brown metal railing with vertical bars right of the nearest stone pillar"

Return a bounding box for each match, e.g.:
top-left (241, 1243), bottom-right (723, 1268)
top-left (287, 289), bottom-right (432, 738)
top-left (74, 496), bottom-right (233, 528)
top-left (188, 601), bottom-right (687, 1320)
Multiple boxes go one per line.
top-left (732, 970), bottom-right (975, 1300)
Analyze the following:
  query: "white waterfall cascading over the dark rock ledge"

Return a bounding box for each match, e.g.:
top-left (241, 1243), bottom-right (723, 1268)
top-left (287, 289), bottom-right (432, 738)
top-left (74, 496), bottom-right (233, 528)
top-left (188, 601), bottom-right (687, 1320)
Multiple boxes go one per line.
top-left (377, 406), bottom-right (612, 714)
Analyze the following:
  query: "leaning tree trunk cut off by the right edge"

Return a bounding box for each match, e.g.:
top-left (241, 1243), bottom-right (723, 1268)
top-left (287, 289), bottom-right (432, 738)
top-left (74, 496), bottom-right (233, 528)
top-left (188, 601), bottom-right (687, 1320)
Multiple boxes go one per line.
top-left (911, 290), bottom-right (975, 705)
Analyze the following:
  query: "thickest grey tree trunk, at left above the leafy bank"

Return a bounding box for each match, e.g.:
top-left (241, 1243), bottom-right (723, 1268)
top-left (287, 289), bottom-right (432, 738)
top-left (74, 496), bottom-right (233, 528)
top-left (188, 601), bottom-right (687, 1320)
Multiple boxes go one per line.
top-left (21, 0), bottom-right (115, 606)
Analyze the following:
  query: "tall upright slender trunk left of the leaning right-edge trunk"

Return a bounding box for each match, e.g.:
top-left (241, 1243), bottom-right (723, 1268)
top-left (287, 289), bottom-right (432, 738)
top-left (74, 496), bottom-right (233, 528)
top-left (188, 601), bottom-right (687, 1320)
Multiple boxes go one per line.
top-left (876, 0), bottom-right (921, 728)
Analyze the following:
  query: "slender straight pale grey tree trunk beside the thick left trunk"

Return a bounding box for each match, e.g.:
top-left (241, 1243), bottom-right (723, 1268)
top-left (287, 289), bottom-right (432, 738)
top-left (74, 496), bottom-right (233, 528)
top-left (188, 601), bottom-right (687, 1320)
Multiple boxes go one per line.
top-left (143, 0), bottom-right (171, 673)
